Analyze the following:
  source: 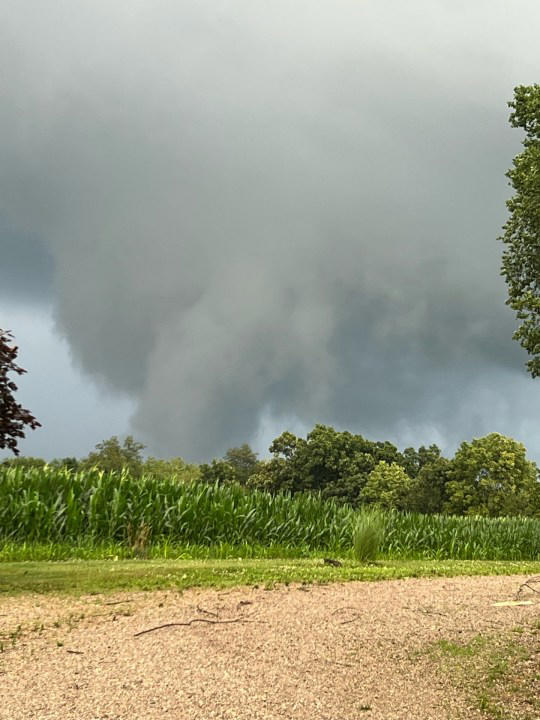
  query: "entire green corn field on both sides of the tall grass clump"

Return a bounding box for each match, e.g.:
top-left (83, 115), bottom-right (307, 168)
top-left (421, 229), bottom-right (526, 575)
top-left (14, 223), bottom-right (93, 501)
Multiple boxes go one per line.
top-left (0, 467), bottom-right (540, 560)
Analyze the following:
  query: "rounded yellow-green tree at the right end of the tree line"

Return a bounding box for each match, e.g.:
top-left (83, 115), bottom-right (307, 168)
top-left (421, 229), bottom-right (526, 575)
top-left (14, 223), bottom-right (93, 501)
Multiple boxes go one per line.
top-left (445, 433), bottom-right (540, 517)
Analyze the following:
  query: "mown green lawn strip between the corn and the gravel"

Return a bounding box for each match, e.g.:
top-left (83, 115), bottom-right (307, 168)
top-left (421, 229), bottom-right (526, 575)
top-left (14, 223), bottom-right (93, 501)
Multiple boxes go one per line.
top-left (0, 558), bottom-right (540, 596)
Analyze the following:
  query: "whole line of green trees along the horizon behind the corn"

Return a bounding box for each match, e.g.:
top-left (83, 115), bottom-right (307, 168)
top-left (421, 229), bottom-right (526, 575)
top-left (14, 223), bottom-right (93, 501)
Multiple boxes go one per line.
top-left (2, 425), bottom-right (540, 517)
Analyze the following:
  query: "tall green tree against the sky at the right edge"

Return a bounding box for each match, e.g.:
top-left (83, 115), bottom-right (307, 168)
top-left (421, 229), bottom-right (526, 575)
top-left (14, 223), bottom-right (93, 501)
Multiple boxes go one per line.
top-left (502, 84), bottom-right (540, 377)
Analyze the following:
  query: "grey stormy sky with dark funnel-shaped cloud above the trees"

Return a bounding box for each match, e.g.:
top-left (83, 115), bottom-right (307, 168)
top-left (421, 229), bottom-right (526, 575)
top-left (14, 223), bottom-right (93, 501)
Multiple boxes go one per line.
top-left (0, 0), bottom-right (540, 461)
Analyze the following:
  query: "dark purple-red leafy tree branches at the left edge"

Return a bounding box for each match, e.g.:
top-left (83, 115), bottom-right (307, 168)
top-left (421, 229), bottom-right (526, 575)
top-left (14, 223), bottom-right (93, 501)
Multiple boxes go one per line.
top-left (0, 329), bottom-right (41, 455)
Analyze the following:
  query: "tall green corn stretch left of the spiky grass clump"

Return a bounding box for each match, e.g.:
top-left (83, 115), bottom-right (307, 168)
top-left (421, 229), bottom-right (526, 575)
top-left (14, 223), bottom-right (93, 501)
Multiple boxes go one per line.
top-left (0, 468), bottom-right (352, 548)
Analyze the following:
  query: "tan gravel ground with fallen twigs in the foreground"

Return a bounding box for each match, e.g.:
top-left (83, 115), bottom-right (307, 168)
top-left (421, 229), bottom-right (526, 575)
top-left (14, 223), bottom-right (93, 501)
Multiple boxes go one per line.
top-left (0, 576), bottom-right (540, 720)
